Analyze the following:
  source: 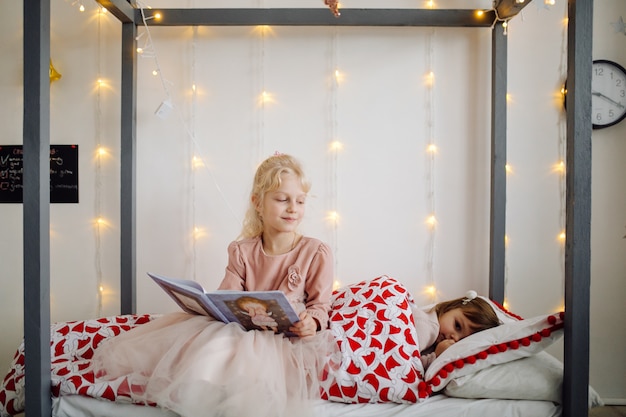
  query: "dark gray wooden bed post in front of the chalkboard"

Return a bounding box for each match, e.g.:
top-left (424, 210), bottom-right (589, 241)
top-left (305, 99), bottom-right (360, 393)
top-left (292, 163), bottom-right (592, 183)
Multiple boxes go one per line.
top-left (22, 0), bottom-right (52, 416)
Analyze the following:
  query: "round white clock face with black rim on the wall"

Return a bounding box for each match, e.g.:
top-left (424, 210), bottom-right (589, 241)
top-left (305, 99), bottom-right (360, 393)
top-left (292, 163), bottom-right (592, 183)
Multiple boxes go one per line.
top-left (591, 60), bottom-right (626, 129)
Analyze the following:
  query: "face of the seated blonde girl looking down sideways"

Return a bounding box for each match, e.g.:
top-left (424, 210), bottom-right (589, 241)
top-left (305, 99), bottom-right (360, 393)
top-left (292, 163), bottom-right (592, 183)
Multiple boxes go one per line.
top-left (257, 173), bottom-right (306, 233)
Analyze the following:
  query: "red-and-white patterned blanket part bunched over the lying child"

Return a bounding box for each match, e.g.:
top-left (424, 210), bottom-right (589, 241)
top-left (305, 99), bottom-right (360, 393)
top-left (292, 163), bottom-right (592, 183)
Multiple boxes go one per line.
top-left (320, 276), bottom-right (429, 403)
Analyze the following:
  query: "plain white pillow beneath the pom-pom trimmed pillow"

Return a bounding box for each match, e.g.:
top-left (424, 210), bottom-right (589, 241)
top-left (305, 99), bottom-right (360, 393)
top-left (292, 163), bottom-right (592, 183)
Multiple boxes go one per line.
top-left (444, 352), bottom-right (602, 407)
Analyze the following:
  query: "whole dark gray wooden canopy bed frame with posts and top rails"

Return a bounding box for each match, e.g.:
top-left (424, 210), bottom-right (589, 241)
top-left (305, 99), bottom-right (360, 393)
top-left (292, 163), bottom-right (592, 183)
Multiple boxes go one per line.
top-left (23, 0), bottom-right (593, 417)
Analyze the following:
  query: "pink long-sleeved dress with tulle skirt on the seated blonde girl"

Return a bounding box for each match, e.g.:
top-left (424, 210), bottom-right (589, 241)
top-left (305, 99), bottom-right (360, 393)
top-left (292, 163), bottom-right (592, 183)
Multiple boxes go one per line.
top-left (94, 237), bottom-right (336, 417)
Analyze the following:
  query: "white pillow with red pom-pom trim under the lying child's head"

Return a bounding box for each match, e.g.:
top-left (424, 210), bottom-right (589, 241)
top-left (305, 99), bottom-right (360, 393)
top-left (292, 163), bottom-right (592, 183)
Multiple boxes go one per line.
top-left (424, 304), bottom-right (563, 392)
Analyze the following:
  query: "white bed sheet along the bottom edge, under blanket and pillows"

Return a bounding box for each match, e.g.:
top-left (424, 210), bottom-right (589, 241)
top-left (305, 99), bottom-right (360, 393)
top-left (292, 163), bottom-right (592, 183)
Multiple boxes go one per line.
top-left (52, 395), bottom-right (561, 417)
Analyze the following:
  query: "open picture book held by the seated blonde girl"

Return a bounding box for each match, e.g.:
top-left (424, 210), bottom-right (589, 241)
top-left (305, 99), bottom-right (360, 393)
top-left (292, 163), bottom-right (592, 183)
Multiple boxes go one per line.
top-left (148, 272), bottom-right (300, 336)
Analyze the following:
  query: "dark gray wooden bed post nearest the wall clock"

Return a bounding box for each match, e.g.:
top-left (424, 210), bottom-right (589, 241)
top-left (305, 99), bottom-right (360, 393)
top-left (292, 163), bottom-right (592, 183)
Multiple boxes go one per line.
top-left (563, 0), bottom-right (593, 417)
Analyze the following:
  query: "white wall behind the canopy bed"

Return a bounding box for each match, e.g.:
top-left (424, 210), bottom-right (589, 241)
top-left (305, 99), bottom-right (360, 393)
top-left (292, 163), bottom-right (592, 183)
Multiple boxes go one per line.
top-left (0, 0), bottom-right (626, 400)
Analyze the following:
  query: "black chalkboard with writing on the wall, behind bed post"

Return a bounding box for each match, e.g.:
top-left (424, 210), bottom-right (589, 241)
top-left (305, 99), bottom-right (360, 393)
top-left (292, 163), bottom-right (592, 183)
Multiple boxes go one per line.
top-left (0, 145), bottom-right (78, 203)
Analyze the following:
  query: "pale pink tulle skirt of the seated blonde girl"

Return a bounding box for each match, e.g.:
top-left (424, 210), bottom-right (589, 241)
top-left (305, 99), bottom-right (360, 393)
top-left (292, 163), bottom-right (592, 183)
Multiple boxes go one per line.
top-left (93, 313), bottom-right (337, 417)
